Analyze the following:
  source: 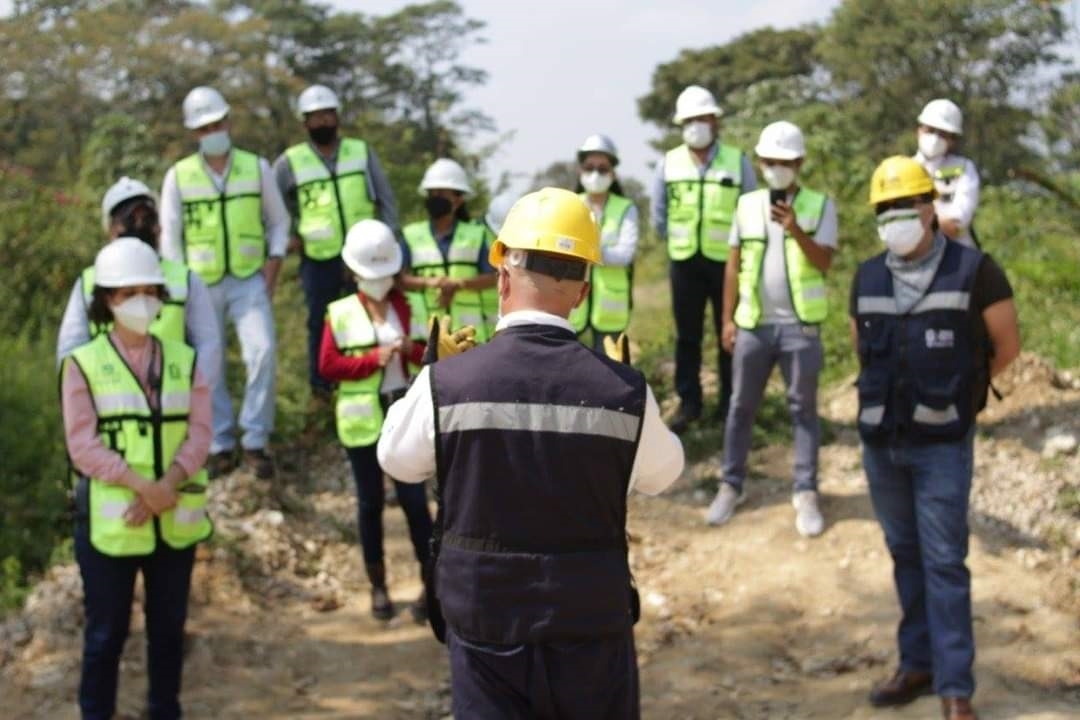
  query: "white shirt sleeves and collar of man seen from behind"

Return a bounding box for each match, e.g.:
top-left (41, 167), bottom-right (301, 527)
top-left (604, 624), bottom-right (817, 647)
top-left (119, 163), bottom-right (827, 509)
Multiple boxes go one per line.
top-left (377, 310), bottom-right (685, 495)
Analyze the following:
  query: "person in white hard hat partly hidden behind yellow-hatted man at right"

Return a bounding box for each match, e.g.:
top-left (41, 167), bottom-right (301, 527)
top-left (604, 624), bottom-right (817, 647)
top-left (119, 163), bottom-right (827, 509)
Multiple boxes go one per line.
top-left (915, 98), bottom-right (980, 247)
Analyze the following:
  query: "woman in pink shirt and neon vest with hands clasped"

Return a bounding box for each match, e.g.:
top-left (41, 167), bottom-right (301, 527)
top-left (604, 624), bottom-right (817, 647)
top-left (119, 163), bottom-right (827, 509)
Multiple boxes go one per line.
top-left (60, 237), bottom-right (212, 718)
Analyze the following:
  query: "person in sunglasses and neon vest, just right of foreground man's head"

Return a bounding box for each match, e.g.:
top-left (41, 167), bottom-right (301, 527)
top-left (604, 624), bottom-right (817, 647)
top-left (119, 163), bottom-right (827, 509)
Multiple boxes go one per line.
top-left (569, 135), bottom-right (639, 351)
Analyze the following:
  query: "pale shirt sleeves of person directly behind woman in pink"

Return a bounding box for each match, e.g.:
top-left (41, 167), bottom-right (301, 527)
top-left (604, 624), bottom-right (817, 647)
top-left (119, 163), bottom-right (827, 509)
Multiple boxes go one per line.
top-left (56, 271), bottom-right (221, 388)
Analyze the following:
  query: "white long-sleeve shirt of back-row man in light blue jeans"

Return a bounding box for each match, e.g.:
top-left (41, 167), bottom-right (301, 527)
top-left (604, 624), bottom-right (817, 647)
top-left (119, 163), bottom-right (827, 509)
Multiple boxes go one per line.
top-left (158, 151), bottom-right (289, 262)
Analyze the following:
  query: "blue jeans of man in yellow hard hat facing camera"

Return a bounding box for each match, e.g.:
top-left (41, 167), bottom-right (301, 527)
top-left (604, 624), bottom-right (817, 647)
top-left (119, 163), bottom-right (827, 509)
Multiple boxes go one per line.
top-left (863, 432), bottom-right (975, 697)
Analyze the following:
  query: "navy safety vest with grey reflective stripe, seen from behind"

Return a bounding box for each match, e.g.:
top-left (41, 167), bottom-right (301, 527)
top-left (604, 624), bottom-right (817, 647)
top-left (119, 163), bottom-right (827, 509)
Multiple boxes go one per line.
top-left (431, 325), bottom-right (646, 644)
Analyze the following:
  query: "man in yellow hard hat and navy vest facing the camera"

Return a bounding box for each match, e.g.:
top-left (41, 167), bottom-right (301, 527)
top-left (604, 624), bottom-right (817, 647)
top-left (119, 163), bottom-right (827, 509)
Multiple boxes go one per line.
top-left (850, 155), bottom-right (1020, 720)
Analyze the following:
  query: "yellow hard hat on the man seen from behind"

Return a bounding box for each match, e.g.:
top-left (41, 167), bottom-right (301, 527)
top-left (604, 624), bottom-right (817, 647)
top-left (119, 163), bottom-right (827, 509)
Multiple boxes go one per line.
top-left (488, 188), bottom-right (600, 268)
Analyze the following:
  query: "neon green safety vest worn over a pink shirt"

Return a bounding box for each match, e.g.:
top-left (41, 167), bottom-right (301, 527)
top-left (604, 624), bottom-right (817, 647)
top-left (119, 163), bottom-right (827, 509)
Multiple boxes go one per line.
top-left (68, 334), bottom-right (213, 556)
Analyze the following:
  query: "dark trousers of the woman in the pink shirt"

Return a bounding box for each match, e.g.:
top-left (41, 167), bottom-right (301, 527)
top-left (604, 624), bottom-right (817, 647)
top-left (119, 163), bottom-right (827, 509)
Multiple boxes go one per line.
top-left (75, 525), bottom-right (195, 720)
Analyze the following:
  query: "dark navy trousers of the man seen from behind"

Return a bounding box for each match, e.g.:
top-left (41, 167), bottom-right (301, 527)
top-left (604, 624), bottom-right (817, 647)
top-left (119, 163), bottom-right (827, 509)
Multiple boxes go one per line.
top-left (447, 629), bottom-right (642, 720)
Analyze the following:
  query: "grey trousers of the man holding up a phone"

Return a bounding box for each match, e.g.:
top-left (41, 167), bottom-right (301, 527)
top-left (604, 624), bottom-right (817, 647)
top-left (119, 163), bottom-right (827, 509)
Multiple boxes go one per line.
top-left (724, 324), bottom-right (824, 492)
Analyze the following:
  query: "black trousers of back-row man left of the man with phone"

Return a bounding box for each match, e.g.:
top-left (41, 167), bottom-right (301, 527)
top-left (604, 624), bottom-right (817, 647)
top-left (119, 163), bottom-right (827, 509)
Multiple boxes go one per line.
top-left (670, 253), bottom-right (731, 410)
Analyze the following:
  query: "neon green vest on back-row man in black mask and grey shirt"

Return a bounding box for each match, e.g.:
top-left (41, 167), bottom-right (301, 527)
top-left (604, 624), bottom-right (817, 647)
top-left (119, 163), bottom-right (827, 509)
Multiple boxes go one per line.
top-left (285, 138), bottom-right (375, 260)
